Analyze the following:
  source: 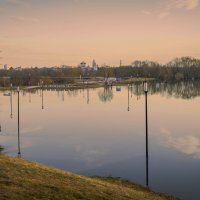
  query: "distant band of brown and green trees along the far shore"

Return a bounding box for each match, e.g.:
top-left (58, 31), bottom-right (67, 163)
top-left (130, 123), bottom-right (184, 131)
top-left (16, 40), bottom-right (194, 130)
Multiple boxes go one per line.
top-left (0, 57), bottom-right (200, 86)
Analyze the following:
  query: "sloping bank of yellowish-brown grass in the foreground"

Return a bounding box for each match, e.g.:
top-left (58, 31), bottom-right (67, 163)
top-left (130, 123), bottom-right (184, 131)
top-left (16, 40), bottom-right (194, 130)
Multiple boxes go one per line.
top-left (0, 154), bottom-right (176, 200)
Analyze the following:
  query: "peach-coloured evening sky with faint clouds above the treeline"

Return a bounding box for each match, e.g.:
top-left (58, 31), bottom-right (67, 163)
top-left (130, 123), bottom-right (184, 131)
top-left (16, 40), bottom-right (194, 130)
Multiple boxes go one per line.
top-left (0, 0), bottom-right (200, 67)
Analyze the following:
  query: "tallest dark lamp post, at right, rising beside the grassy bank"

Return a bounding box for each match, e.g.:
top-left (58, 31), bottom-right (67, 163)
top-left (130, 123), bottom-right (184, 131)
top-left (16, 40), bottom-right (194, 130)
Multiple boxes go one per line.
top-left (144, 81), bottom-right (149, 187)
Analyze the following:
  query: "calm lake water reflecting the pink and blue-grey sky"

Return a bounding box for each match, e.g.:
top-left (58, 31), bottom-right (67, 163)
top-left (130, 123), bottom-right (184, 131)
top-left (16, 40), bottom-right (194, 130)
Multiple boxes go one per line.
top-left (0, 82), bottom-right (200, 200)
